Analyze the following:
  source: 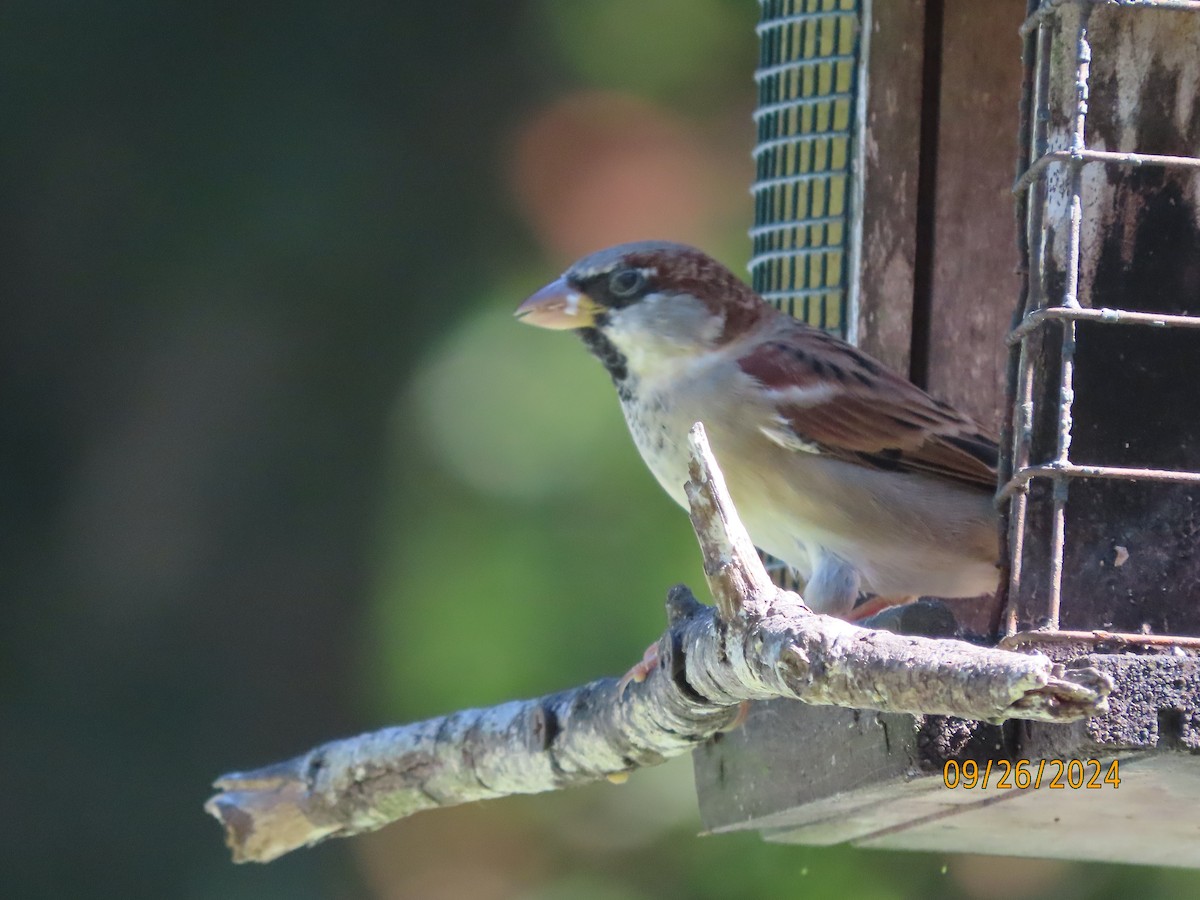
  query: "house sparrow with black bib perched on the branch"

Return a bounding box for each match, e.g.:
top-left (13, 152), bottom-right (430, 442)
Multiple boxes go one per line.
top-left (516, 241), bottom-right (998, 618)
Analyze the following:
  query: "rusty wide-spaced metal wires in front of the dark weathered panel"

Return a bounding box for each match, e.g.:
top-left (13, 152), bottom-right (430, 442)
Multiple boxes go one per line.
top-left (998, 0), bottom-right (1200, 644)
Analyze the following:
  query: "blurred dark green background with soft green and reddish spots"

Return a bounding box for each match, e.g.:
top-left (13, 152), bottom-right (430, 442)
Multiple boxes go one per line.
top-left (0, 0), bottom-right (1200, 900)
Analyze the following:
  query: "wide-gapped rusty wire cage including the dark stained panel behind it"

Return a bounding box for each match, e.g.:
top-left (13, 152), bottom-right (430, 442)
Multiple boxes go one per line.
top-left (1000, 0), bottom-right (1200, 647)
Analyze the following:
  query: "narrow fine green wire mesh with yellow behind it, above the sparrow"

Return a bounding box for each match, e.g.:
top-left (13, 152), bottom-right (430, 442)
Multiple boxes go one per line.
top-left (750, 0), bottom-right (863, 337)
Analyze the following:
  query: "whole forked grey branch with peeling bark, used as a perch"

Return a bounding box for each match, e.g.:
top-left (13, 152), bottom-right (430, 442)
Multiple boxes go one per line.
top-left (205, 425), bottom-right (1111, 862)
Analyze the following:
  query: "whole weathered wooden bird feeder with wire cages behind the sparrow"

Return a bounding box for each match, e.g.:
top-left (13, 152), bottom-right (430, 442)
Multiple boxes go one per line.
top-left (695, 0), bottom-right (1200, 866)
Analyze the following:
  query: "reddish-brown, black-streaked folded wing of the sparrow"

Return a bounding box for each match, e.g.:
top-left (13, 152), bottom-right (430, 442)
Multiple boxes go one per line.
top-left (738, 318), bottom-right (996, 491)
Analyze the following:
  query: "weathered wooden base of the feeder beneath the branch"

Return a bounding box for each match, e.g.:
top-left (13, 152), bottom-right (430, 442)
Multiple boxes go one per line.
top-left (694, 619), bottom-right (1200, 868)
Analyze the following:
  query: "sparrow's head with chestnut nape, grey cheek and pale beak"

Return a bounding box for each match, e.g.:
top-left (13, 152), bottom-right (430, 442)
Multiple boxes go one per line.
top-left (516, 241), bottom-right (770, 380)
